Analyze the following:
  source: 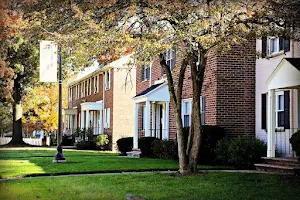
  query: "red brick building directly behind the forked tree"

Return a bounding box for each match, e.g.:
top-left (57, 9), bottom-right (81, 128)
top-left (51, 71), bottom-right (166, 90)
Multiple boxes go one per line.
top-left (134, 41), bottom-right (256, 148)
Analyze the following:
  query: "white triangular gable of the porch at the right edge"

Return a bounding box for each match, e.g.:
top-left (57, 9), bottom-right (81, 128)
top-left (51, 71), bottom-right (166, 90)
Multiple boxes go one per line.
top-left (267, 59), bottom-right (300, 89)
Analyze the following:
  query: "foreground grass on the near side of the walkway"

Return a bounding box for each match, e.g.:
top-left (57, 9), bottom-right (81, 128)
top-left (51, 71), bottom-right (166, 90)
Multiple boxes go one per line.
top-left (0, 172), bottom-right (300, 200)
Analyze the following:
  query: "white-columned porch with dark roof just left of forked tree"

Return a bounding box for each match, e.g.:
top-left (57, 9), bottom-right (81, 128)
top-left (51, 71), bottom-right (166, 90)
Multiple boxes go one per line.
top-left (133, 82), bottom-right (170, 149)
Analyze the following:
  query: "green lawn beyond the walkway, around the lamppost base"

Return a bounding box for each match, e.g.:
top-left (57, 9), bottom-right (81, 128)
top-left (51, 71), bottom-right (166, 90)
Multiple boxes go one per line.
top-left (0, 148), bottom-right (224, 178)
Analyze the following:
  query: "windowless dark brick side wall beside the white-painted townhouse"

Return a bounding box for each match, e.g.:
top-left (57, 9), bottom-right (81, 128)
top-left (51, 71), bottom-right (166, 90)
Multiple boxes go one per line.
top-left (216, 40), bottom-right (255, 137)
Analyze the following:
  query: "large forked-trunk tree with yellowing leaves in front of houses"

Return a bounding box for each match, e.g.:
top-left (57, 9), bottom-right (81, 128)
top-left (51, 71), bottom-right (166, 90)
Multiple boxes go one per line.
top-left (20, 0), bottom-right (298, 174)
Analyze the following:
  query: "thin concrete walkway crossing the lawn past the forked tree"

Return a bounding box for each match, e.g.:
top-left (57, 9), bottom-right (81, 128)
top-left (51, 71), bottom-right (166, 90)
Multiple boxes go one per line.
top-left (0, 169), bottom-right (291, 181)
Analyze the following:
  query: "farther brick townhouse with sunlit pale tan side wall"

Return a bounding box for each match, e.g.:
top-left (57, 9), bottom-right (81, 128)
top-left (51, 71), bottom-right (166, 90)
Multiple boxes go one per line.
top-left (64, 55), bottom-right (136, 150)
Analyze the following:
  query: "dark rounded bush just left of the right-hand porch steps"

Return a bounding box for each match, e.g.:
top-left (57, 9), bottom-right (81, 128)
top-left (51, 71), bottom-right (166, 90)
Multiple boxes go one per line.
top-left (216, 137), bottom-right (267, 169)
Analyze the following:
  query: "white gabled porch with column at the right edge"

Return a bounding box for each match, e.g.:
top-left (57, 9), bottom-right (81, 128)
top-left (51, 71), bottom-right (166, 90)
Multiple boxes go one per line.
top-left (267, 58), bottom-right (300, 158)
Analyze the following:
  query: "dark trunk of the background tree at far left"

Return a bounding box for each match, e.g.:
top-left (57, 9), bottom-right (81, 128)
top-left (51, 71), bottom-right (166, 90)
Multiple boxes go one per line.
top-left (9, 78), bottom-right (25, 145)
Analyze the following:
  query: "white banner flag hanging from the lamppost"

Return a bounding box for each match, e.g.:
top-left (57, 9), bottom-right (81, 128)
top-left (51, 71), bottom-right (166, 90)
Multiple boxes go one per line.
top-left (40, 40), bottom-right (57, 82)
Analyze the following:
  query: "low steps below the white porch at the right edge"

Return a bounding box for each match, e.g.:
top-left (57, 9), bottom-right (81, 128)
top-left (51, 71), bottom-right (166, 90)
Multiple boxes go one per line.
top-left (254, 163), bottom-right (300, 174)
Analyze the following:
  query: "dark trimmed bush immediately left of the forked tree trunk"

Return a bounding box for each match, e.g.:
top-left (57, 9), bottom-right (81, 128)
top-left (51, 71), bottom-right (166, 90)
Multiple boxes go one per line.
top-left (152, 140), bottom-right (178, 160)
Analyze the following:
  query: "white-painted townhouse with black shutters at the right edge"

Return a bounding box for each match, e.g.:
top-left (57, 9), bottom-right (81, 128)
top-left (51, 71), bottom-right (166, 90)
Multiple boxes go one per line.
top-left (255, 37), bottom-right (300, 157)
